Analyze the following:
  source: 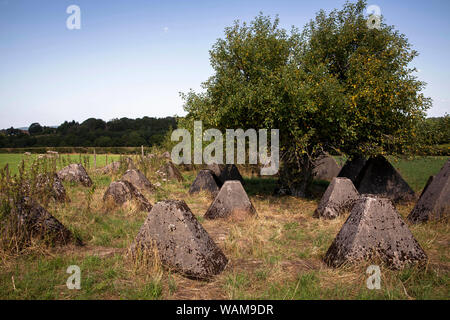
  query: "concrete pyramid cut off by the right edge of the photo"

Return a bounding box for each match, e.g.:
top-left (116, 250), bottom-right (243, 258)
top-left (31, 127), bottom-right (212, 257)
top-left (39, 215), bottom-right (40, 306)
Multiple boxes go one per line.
top-left (408, 160), bottom-right (450, 223)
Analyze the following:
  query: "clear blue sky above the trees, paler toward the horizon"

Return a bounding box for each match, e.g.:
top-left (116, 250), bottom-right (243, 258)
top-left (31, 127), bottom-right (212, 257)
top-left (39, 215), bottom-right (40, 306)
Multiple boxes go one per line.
top-left (0, 0), bottom-right (450, 128)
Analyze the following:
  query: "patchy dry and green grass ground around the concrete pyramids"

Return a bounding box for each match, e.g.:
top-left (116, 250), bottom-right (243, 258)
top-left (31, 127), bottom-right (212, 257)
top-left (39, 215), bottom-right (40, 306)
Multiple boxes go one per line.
top-left (0, 155), bottom-right (450, 299)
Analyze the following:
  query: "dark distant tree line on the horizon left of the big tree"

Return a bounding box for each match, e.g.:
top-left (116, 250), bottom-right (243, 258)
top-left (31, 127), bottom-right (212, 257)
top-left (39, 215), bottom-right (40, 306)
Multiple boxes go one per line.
top-left (0, 117), bottom-right (177, 148)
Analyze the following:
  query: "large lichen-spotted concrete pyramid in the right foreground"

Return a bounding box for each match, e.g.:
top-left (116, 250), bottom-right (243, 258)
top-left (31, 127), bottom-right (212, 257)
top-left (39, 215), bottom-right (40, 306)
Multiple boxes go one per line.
top-left (325, 196), bottom-right (427, 269)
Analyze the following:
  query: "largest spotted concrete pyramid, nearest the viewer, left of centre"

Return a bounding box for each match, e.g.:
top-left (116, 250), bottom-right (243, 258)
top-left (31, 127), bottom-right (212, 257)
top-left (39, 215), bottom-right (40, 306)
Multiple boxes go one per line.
top-left (131, 200), bottom-right (228, 279)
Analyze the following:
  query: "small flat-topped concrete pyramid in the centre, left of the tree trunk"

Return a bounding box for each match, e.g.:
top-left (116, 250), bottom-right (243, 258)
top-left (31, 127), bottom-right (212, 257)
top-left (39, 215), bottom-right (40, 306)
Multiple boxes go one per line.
top-left (205, 180), bottom-right (256, 219)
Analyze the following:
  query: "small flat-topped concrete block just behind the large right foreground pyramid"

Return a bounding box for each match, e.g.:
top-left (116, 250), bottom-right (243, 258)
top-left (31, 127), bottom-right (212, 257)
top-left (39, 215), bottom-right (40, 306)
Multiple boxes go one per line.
top-left (314, 178), bottom-right (359, 219)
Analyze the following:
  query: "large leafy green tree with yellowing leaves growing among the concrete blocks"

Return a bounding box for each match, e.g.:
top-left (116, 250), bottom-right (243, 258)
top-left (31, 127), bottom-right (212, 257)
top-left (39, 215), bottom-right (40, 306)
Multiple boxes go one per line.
top-left (183, 1), bottom-right (431, 195)
